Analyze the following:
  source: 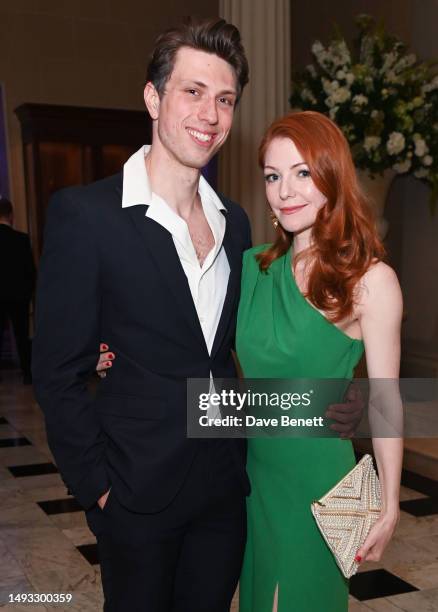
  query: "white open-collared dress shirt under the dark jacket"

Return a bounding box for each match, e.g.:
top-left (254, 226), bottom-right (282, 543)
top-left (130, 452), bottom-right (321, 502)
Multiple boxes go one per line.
top-left (122, 145), bottom-right (230, 353)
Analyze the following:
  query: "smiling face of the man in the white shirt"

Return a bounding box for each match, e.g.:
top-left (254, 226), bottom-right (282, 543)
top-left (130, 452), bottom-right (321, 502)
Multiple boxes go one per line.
top-left (145, 47), bottom-right (237, 169)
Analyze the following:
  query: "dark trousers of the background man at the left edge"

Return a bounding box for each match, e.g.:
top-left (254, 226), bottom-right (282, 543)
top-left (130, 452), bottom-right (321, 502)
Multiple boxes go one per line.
top-left (0, 300), bottom-right (31, 375)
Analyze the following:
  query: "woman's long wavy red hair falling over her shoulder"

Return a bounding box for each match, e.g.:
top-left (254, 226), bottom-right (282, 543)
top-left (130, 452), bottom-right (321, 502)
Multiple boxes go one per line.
top-left (257, 111), bottom-right (385, 322)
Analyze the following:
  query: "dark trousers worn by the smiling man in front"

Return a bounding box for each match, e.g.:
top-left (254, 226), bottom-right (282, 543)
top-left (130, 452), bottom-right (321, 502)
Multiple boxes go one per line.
top-left (87, 440), bottom-right (246, 612)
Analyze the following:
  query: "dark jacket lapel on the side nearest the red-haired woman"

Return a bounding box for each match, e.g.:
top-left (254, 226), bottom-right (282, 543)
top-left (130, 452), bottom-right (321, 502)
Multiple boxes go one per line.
top-left (211, 213), bottom-right (242, 357)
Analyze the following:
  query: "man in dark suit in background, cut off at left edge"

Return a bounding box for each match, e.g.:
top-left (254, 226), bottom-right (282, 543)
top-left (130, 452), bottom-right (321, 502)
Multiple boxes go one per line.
top-left (0, 198), bottom-right (35, 384)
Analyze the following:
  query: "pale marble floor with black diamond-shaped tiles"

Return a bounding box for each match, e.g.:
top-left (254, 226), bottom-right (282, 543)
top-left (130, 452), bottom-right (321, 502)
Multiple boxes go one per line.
top-left (0, 371), bottom-right (438, 612)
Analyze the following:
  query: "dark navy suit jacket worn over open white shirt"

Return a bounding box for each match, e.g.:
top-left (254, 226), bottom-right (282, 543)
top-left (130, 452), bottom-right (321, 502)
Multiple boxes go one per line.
top-left (33, 174), bottom-right (250, 512)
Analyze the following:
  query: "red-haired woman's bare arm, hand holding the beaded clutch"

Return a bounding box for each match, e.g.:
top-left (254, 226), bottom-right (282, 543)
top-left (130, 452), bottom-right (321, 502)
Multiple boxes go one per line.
top-left (358, 262), bottom-right (403, 561)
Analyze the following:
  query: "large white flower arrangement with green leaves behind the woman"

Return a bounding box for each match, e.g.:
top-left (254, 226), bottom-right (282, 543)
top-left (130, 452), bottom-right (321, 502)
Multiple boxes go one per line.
top-left (290, 15), bottom-right (438, 210)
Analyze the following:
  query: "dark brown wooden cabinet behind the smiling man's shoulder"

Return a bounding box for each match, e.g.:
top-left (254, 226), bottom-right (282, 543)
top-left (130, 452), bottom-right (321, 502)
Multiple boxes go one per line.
top-left (15, 104), bottom-right (151, 261)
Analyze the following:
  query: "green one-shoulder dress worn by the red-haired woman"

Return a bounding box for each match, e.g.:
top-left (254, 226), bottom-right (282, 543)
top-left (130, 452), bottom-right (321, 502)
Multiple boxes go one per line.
top-left (236, 245), bottom-right (363, 612)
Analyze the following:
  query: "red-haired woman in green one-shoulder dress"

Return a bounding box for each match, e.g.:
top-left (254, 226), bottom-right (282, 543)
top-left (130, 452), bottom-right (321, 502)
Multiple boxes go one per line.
top-left (99, 112), bottom-right (402, 612)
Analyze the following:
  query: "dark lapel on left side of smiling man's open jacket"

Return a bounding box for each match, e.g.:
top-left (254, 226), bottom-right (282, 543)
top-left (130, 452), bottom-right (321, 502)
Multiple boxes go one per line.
top-left (124, 205), bottom-right (207, 350)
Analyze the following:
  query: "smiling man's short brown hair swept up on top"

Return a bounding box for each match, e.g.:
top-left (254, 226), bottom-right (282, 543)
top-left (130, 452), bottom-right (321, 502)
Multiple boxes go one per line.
top-left (146, 17), bottom-right (249, 100)
